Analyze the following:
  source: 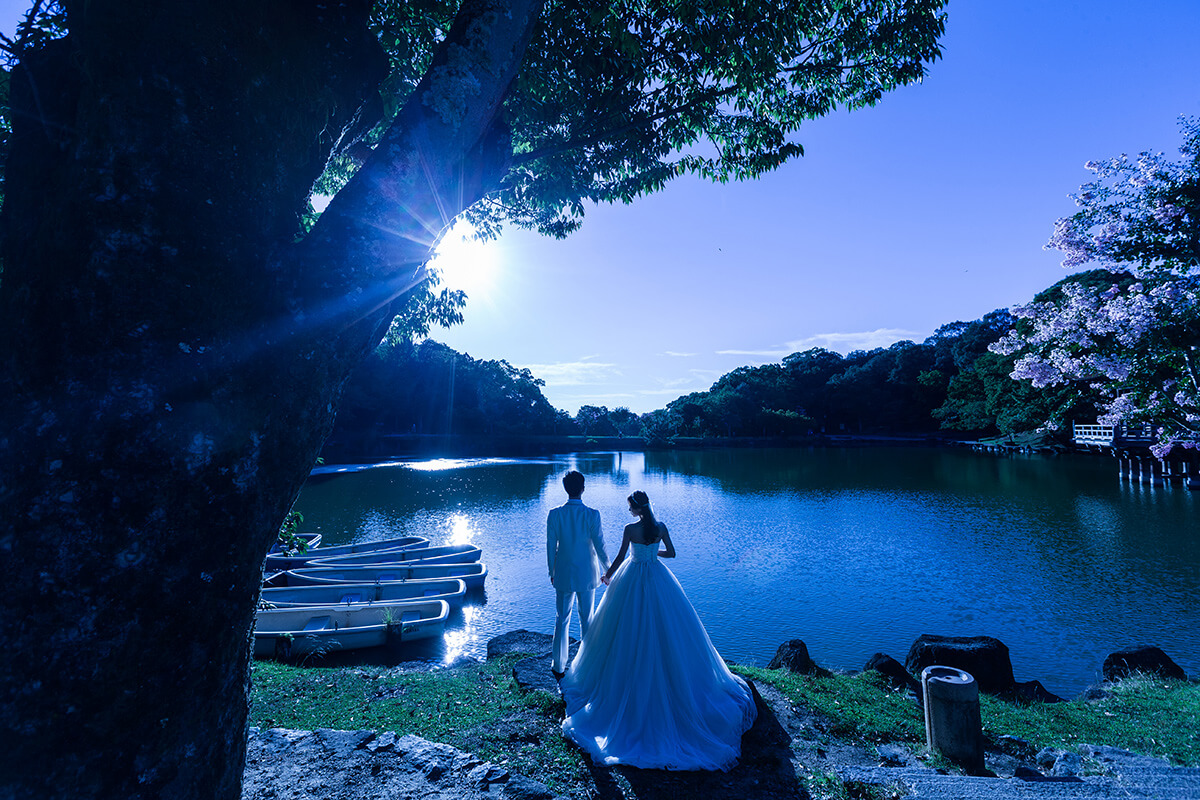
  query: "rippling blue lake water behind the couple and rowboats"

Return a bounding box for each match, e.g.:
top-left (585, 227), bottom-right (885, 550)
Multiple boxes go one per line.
top-left (296, 447), bottom-right (1200, 696)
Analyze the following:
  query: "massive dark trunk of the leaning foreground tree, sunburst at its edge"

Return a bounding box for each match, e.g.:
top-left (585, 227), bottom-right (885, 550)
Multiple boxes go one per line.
top-left (0, 0), bottom-right (538, 800)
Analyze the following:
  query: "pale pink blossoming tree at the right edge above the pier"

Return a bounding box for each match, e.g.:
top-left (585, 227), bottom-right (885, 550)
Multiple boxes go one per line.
top-left (991, 118), bottom-right (1200, 458)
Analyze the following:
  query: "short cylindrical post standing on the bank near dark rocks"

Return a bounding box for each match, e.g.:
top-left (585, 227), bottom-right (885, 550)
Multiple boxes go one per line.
top-left (920, 667), bottom-right (983, 772)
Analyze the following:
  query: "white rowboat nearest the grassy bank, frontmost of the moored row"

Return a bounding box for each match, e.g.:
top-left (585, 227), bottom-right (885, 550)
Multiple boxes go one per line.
top-left (254, 600), bottom-right (450, 658)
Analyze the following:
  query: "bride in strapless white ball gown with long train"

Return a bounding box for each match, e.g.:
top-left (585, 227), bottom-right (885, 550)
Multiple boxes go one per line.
top-left (560, 492), bottom-right (757, 770)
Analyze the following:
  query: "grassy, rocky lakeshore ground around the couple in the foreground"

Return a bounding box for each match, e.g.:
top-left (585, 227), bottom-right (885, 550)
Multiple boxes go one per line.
top-left (244, 632), bottom-right (1200, 800)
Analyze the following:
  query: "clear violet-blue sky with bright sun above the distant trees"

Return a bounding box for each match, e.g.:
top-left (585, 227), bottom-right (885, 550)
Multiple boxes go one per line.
top-left (2, 0), bottom-right (1200, 413)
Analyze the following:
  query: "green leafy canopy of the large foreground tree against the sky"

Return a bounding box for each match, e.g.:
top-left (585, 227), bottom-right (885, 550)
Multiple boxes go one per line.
top-left (317, 0), bottom-right (944, 236)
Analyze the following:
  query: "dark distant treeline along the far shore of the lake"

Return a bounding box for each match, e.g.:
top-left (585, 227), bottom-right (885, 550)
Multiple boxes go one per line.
top-left (334, 273), bottom-right (1096, 443)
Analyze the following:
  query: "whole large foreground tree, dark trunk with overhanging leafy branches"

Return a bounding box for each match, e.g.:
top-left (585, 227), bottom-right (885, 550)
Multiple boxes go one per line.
top-left (0, 0), bottom-right (943, 799)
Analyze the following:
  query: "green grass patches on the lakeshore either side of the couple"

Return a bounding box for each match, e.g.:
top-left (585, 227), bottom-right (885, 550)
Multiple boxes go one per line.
top-left (251, 656), bottom-right (1200, 798)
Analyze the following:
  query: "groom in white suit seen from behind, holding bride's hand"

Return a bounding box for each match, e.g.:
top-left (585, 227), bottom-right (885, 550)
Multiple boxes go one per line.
top-left (546, 469), bottom-right (608, 679)
